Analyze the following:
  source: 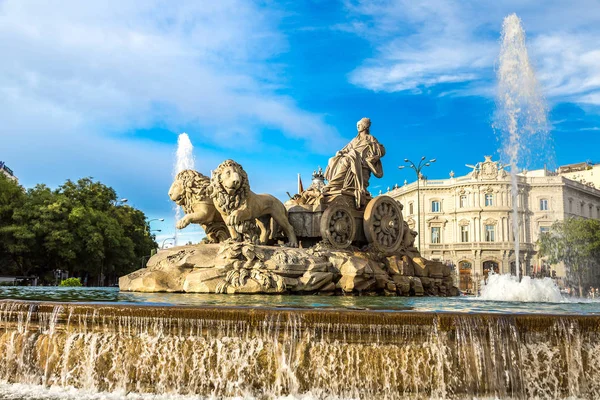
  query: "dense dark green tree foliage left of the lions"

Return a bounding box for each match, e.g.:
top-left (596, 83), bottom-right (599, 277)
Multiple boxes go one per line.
top-left (0, 174), bottom-right (157, 285)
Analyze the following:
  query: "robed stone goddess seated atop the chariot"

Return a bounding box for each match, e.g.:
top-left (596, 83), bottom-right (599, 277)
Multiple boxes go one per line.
top-left (323, 118), bottom-right (385, 208)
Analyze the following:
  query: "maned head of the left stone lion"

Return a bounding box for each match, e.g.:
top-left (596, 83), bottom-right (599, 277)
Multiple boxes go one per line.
top-left (169, 169), bottom-right (210, 214)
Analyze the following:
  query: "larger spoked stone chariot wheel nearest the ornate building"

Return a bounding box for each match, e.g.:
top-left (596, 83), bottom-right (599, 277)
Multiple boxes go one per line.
top-left (363, 196), bottom-right (404, 254)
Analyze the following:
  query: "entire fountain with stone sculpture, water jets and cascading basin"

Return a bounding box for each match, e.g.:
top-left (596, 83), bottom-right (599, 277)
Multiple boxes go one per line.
top-left (0, 12), bottom-right (600, 400)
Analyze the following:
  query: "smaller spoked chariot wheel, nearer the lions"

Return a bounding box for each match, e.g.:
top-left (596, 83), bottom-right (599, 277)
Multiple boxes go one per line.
top-left (320, 203), bottom-right (356, 249)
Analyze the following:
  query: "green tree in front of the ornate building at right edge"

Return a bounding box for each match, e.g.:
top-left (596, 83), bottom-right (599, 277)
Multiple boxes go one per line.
top-left (538, 218), bottom-right (600, 297)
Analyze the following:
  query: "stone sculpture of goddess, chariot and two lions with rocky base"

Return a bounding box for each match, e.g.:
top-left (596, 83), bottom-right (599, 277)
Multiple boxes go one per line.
top-left (119, 118), bottom-right (458, 296)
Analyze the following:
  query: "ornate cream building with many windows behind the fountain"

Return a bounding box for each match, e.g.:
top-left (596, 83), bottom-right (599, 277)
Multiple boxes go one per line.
top-left (387, 156), bottom-right (600, 290)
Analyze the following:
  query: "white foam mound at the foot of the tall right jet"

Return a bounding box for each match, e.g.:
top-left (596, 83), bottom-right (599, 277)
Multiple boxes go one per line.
top-left (479, 273), bottom-right (568, 303)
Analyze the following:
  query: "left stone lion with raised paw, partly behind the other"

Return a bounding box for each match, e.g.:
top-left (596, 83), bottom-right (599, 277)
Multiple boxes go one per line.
top-left (169, 169), bottom-right (229, 243)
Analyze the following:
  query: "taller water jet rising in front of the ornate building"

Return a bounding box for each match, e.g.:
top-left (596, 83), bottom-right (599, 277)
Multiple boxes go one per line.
top-left (494, 14), bottom-right (548, 277)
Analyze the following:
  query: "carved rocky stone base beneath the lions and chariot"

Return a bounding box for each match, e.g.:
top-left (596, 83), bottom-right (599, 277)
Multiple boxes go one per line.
top-left (119, 242), bottom-right (459, 296)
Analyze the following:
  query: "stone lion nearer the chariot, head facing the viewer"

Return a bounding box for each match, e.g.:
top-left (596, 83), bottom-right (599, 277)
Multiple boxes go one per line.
top-left (211, 160), bottom-right (298, 247)
